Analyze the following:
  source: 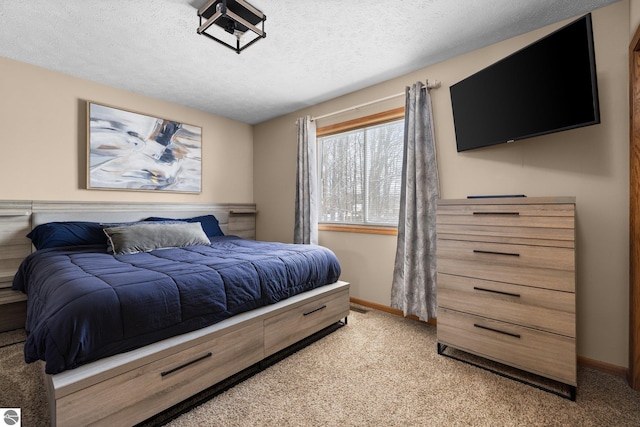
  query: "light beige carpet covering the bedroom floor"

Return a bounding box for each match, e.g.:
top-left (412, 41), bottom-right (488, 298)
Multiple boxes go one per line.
top-left (0, 310), bottom-right (640, 427)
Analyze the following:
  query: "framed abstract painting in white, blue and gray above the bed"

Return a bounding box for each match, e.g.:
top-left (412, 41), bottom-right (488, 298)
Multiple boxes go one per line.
top-left (87, 101), bottom-right (202, 193)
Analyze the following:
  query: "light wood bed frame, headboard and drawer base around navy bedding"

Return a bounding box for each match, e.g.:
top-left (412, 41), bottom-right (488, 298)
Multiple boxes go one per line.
top-left (2, 202), bottom-right (349, 426)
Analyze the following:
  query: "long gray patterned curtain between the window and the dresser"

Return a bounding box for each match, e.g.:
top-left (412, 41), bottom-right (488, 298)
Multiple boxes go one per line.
top-left (391, 82), bottom-right (440, 321)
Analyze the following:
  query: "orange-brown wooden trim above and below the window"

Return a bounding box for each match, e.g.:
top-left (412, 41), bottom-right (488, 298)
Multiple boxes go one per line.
top-left (316, 107), bottom-right (405, 235)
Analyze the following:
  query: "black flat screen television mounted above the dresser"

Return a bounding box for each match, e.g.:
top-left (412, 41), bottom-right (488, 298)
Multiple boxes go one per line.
top-left (450, 14), bottom-right (600, 152)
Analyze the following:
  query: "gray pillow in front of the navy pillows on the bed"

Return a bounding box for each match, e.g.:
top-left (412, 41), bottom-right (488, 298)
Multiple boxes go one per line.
top-left (104, 222), bottom-right (211, 255)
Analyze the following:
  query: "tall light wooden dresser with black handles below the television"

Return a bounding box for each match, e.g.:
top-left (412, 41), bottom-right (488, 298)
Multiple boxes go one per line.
top-left (437, 197), bottom-right (577, 400)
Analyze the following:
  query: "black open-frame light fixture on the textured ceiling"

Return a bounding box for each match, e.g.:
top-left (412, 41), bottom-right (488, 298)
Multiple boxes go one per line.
top-left (198, 0), bottom-right (267, 53)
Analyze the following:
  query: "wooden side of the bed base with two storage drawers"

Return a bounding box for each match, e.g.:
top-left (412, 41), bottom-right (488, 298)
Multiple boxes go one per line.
top-left (48, 281), bottom-right (349, 426)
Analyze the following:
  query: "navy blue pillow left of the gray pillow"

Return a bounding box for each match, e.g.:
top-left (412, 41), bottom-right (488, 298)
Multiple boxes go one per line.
top-left (27, 221), bottom-right (107, 249)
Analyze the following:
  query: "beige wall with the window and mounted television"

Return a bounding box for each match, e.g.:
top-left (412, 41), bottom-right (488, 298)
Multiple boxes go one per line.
top-left (254, 0), bottom-right (635, 367)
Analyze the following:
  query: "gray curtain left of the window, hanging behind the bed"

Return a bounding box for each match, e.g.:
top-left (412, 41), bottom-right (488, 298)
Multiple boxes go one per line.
top-left (293, 116), bottom-right (318, 245)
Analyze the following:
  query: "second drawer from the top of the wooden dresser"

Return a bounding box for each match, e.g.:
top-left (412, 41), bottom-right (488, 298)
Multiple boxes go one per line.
top-left (437, 239), bottom-right (575, 292)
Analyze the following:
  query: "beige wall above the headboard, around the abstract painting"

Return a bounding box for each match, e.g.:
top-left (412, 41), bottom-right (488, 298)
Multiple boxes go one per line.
top-left (0, 57), bottom-right (253, 203)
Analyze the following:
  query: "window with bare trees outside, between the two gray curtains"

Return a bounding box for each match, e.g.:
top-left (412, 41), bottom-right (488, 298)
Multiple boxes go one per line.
top-left (317, 108), bottom-right (404, 231)
